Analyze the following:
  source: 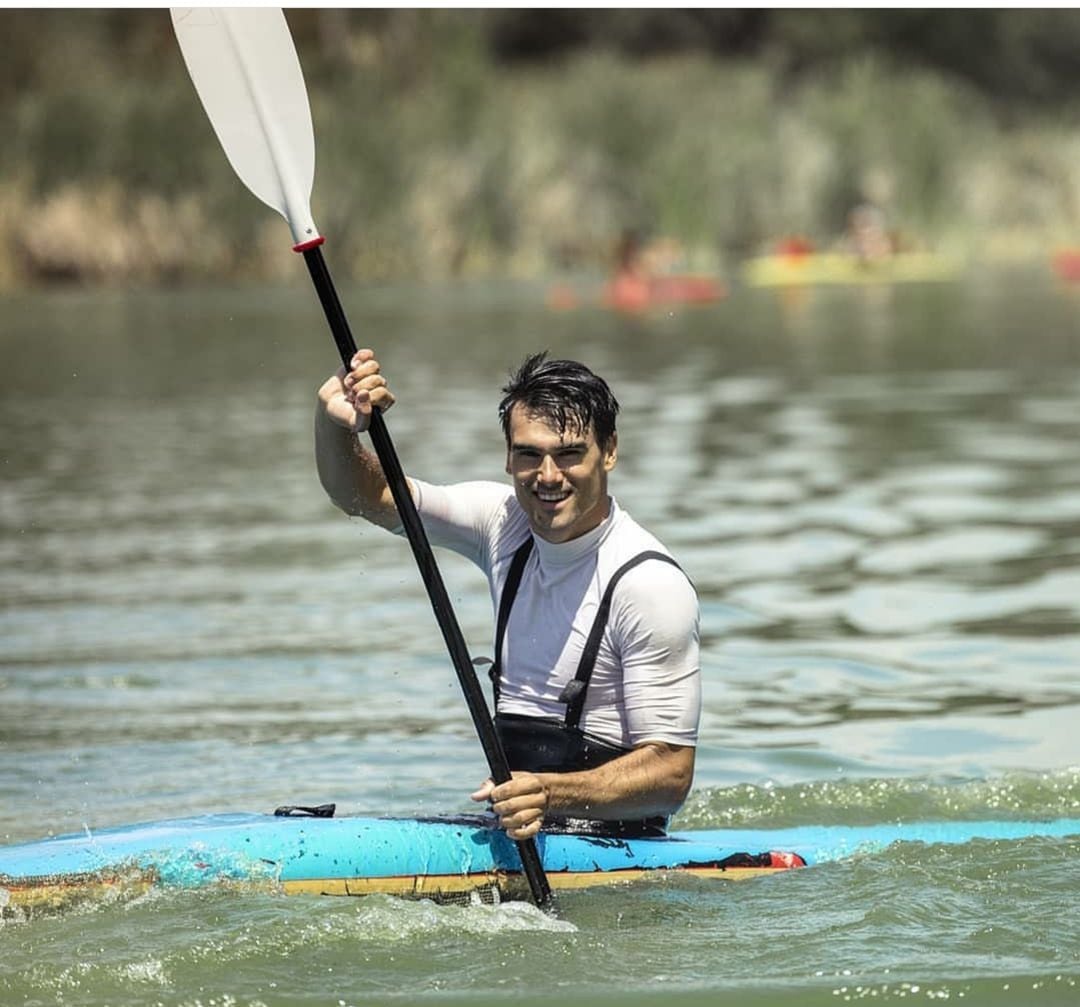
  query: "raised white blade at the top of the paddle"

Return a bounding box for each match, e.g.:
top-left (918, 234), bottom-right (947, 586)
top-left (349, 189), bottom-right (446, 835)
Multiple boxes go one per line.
top-left (170, 8), bottom-right (320, 245)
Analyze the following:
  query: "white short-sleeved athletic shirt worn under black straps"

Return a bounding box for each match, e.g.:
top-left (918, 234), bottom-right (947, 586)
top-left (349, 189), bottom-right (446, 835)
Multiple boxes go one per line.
top-left (409, 479), bottom-right (701, 748)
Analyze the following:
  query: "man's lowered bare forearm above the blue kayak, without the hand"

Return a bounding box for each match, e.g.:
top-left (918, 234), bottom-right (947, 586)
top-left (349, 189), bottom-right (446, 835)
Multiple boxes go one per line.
top-left (537, 743), bottom-right (694, 819)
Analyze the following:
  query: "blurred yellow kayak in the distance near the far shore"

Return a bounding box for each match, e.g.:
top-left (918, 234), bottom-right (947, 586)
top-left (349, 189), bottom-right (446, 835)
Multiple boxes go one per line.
top-left (742, 252), bottom-right (962, 286)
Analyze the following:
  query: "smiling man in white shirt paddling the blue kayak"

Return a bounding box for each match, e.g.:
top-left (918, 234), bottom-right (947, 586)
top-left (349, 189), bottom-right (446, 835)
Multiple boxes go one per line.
top-left (315, 350), bottom-right (701, 840)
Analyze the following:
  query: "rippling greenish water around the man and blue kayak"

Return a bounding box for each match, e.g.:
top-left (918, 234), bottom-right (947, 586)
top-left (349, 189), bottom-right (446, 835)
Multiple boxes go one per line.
top-left (0, 271), bottom-right (1080, 1007)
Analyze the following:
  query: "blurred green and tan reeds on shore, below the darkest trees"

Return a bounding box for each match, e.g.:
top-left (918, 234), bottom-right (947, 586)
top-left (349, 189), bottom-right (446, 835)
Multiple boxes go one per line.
top-left (6, 12), bottom-right (1080, 288)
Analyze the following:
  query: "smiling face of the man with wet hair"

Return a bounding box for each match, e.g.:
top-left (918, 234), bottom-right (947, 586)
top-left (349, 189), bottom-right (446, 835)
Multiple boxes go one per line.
top-left (507, 403), bottom-right (616, 542)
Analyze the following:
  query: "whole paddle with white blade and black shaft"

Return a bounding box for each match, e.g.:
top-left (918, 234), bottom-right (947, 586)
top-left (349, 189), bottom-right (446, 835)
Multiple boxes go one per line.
top-left (171, 8), bottom-right (551, 907)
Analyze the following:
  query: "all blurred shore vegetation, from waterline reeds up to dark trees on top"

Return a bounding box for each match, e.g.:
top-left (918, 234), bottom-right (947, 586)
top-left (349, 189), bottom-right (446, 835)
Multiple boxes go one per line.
top-left (6, 9), bottom-right (1080, 286)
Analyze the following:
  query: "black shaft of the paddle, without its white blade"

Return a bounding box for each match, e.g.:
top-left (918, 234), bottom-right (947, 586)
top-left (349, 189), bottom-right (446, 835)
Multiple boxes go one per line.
top-left (303, 245), bottom-right (551, 907)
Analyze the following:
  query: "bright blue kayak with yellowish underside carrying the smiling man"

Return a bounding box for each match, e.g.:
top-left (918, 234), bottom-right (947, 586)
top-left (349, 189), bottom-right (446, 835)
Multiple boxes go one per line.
top-left (0, 805), bottom-right (1080, 915)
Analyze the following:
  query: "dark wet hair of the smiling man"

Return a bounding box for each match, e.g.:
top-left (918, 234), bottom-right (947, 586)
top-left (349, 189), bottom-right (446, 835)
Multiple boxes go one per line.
top-left (499, 352), bottom-right (619, 448)
